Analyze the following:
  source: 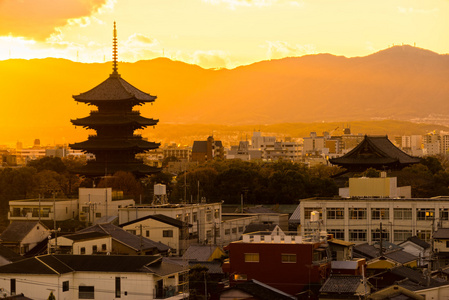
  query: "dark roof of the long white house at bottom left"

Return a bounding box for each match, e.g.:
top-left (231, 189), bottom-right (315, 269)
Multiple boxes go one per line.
top-left (0, 254), bottom-right (186, 276)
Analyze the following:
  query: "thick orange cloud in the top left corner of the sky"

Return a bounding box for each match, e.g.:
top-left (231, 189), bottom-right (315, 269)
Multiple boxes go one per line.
top-left (0, 0), bottom-right (113, 41)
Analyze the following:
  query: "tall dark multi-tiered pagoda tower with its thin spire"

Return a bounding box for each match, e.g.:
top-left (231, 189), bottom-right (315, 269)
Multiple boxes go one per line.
top-left (70, 22), bottom-right (160, 177)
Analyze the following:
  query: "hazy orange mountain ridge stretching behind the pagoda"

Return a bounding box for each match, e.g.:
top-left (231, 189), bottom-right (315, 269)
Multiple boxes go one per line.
top-left (0, 46), bottom-right (449, 143)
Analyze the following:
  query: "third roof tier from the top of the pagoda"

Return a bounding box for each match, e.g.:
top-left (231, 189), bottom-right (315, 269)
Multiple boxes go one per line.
top-left (69, 138), bottom-right (160, 152)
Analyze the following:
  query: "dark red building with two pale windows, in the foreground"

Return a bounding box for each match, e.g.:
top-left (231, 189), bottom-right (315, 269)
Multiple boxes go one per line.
top-left (223, 230), bottom-right (331, 295)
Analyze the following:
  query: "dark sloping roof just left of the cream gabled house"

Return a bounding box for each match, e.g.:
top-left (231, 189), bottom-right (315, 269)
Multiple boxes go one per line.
top-left (78, 224), bottom-right (170, 252)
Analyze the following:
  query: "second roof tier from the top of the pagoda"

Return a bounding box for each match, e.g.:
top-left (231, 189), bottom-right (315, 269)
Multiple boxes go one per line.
top-left (70, 113), bottom-right (159, 127)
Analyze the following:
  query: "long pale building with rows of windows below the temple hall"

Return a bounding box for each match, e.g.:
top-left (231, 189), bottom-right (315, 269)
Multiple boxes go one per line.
top-left (298, 178), bottom-right (449, 244)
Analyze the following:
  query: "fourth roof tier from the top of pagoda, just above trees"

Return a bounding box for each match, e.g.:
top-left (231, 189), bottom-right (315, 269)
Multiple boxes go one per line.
top-left (73, 160), bottom-right (161, 177)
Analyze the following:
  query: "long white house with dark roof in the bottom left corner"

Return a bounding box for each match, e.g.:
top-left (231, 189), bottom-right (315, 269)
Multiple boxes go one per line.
top-left (0, 254), bottom-right (187, 300)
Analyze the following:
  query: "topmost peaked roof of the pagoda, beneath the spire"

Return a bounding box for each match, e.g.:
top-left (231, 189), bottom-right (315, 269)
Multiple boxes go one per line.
top-left (73, 74), bottom-right (157, 104)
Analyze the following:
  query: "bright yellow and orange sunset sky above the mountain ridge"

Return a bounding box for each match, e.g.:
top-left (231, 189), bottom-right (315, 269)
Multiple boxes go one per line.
top-left (0, 0), bottom-right (449, 68)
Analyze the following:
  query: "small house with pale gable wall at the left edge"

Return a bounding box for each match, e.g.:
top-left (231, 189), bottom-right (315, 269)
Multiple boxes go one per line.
top-left (0, 221), bottom-right (50, 255)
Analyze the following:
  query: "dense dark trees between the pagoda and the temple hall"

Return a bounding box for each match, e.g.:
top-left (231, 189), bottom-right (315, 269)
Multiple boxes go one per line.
top-left (170, 160), bottom-right (338, 204)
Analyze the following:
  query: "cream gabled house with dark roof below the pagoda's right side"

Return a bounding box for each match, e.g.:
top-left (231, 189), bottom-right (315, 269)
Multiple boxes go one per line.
top-left (120, 214), bottom-right (192, 255)
